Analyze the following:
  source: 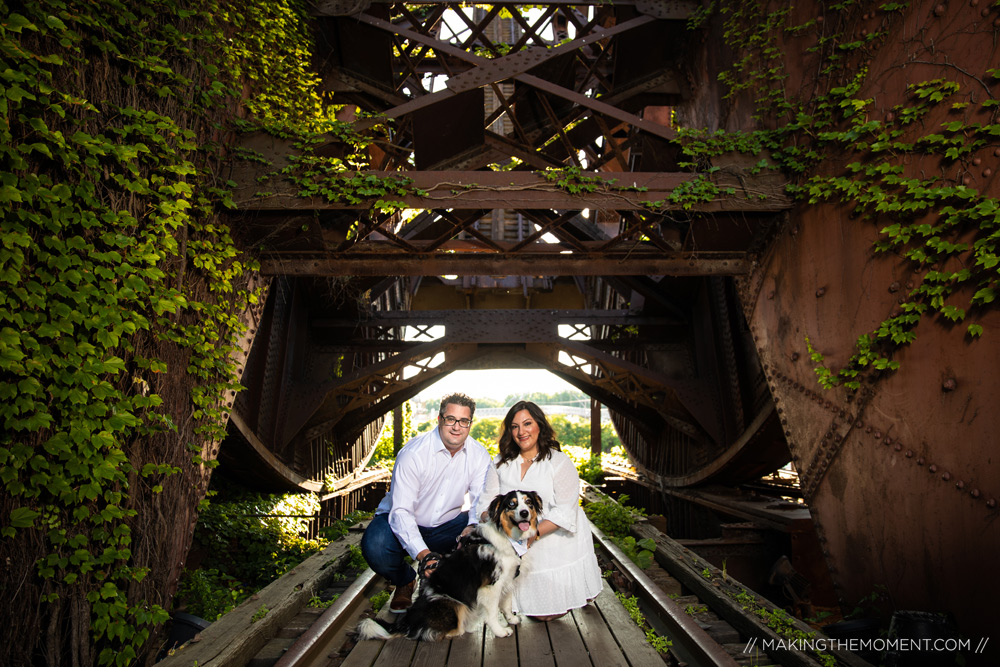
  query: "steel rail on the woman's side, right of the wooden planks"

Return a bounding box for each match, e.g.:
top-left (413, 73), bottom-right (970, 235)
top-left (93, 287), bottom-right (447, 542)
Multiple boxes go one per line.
top-left (590, 524), bottom-right (738, 667)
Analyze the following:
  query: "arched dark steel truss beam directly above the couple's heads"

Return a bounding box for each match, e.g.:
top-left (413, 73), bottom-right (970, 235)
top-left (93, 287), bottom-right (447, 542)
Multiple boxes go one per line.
top-left (292, 310), bottom-right (721, 442)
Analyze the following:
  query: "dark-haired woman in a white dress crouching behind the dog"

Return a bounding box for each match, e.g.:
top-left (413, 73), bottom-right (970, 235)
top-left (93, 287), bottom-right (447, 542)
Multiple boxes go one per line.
top-left (480, 401), bottom-right (604, 621)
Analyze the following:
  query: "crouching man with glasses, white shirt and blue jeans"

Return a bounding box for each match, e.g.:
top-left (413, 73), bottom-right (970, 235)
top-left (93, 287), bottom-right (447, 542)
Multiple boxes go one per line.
top-left (361, 394), bottom-right (491, 613)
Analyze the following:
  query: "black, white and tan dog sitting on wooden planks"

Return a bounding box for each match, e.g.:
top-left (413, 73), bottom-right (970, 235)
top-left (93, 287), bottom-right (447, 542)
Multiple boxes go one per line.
top-left (358, 491), bottom-right (542, 641)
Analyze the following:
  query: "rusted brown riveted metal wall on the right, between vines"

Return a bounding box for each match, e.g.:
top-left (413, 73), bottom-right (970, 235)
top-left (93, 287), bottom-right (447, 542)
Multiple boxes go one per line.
top-left (682, 0), bottom-right (1000, 648)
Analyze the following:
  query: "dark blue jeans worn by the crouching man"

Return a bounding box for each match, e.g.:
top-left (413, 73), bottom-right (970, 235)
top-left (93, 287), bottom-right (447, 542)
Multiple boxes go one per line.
top-left (361, 512), bottom-right (469, 586)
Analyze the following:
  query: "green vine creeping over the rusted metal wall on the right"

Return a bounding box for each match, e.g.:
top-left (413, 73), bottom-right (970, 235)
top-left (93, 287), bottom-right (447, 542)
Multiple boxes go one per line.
top-left (680, 0), bottom-right (1000, 389)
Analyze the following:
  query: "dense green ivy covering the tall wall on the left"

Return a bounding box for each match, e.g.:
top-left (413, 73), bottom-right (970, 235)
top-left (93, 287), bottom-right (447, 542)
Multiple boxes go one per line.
top-left (0, 0), bottom-right (338, 665)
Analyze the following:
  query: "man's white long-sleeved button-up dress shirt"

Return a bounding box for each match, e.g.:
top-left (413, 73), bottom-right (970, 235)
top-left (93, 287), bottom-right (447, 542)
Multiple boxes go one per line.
top-left (375, 428), bottom-right (492, 558)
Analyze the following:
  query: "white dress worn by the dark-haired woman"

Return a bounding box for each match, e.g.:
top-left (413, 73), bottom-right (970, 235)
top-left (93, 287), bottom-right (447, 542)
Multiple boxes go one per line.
top-left (480, 450), bottom-right (604, 616)
